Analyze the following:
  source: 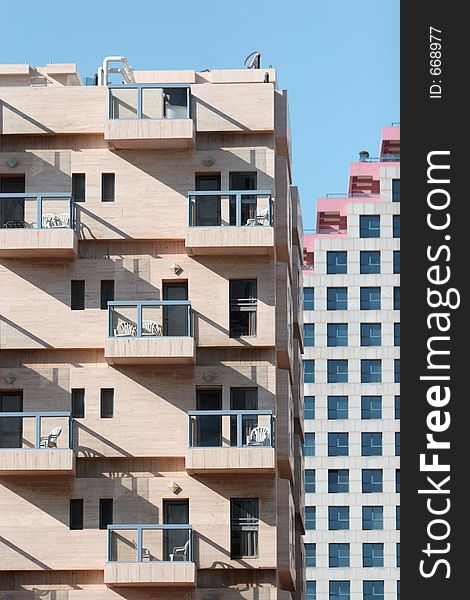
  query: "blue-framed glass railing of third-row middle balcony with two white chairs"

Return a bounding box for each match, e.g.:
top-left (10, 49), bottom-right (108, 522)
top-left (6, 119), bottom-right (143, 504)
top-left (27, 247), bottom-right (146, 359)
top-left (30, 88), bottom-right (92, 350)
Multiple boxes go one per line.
top-left (108, 300), bottom-right (193, 338)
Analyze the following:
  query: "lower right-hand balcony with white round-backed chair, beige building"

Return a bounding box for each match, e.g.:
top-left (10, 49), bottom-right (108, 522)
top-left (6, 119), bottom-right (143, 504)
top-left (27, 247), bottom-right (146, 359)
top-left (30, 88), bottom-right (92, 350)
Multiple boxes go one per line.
top-left (186, 410), bottom-right (276, 474)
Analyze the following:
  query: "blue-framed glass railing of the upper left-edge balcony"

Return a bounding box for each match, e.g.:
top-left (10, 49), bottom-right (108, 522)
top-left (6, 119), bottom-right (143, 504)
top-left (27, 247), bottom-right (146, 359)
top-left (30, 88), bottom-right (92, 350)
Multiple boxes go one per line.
top-left (0, 192), bottom-right (75, 229)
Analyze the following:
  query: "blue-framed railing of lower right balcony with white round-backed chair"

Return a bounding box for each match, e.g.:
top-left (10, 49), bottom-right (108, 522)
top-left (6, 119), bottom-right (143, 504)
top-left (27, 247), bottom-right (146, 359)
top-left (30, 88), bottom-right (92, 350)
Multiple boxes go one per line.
top-left (188, 410), bottom-right (274, 448)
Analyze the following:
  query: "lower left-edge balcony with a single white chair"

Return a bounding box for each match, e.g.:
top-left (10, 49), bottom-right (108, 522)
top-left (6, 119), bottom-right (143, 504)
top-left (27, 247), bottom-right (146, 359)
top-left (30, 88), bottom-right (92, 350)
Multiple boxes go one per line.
top-left (0, 412), bottom-right (75, 476)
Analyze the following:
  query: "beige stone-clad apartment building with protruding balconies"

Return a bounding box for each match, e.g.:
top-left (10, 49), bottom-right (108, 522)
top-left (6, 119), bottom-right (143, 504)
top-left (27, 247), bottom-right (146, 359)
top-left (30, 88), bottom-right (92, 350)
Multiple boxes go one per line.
top-left (0, 57), bottom-right (305, 600)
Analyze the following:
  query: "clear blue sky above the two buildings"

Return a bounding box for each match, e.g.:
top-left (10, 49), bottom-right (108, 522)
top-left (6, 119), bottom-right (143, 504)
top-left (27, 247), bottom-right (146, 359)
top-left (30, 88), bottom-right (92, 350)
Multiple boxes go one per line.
top-left (0, 0), bottom-right (400, 228)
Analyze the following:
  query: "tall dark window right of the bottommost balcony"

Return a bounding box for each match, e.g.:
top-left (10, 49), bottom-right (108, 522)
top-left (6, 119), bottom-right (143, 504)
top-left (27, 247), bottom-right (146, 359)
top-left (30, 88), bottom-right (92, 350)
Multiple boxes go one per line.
top-left (230, 498), bottom-right (259, 558)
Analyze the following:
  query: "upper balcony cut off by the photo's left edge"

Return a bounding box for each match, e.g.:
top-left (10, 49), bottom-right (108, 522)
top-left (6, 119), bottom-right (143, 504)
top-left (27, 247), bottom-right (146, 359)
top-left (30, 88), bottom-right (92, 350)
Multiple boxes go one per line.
top-left (0, 192), bottom-right (78, 259)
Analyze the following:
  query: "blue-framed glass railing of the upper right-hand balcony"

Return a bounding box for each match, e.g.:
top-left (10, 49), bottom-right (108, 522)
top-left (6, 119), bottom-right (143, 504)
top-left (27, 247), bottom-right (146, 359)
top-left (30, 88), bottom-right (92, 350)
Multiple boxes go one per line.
top-left (188, 190), bottom-right (273, 227)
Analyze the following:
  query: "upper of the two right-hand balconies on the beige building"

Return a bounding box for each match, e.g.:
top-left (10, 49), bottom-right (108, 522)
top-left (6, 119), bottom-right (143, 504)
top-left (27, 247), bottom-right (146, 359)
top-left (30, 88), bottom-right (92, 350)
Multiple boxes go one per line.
top-left (186, 190), bottom-right (274, 256)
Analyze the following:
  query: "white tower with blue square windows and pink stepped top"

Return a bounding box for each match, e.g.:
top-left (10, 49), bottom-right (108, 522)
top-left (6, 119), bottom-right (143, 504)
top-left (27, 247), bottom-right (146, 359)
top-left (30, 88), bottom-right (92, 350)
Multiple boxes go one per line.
top-left (303, 126), bottom-right (400, 600)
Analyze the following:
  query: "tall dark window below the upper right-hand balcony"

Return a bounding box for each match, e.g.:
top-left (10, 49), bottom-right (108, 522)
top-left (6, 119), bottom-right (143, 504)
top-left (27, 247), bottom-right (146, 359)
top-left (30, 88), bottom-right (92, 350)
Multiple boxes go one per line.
top-left (229, 279), bottom-right (257, 338)
